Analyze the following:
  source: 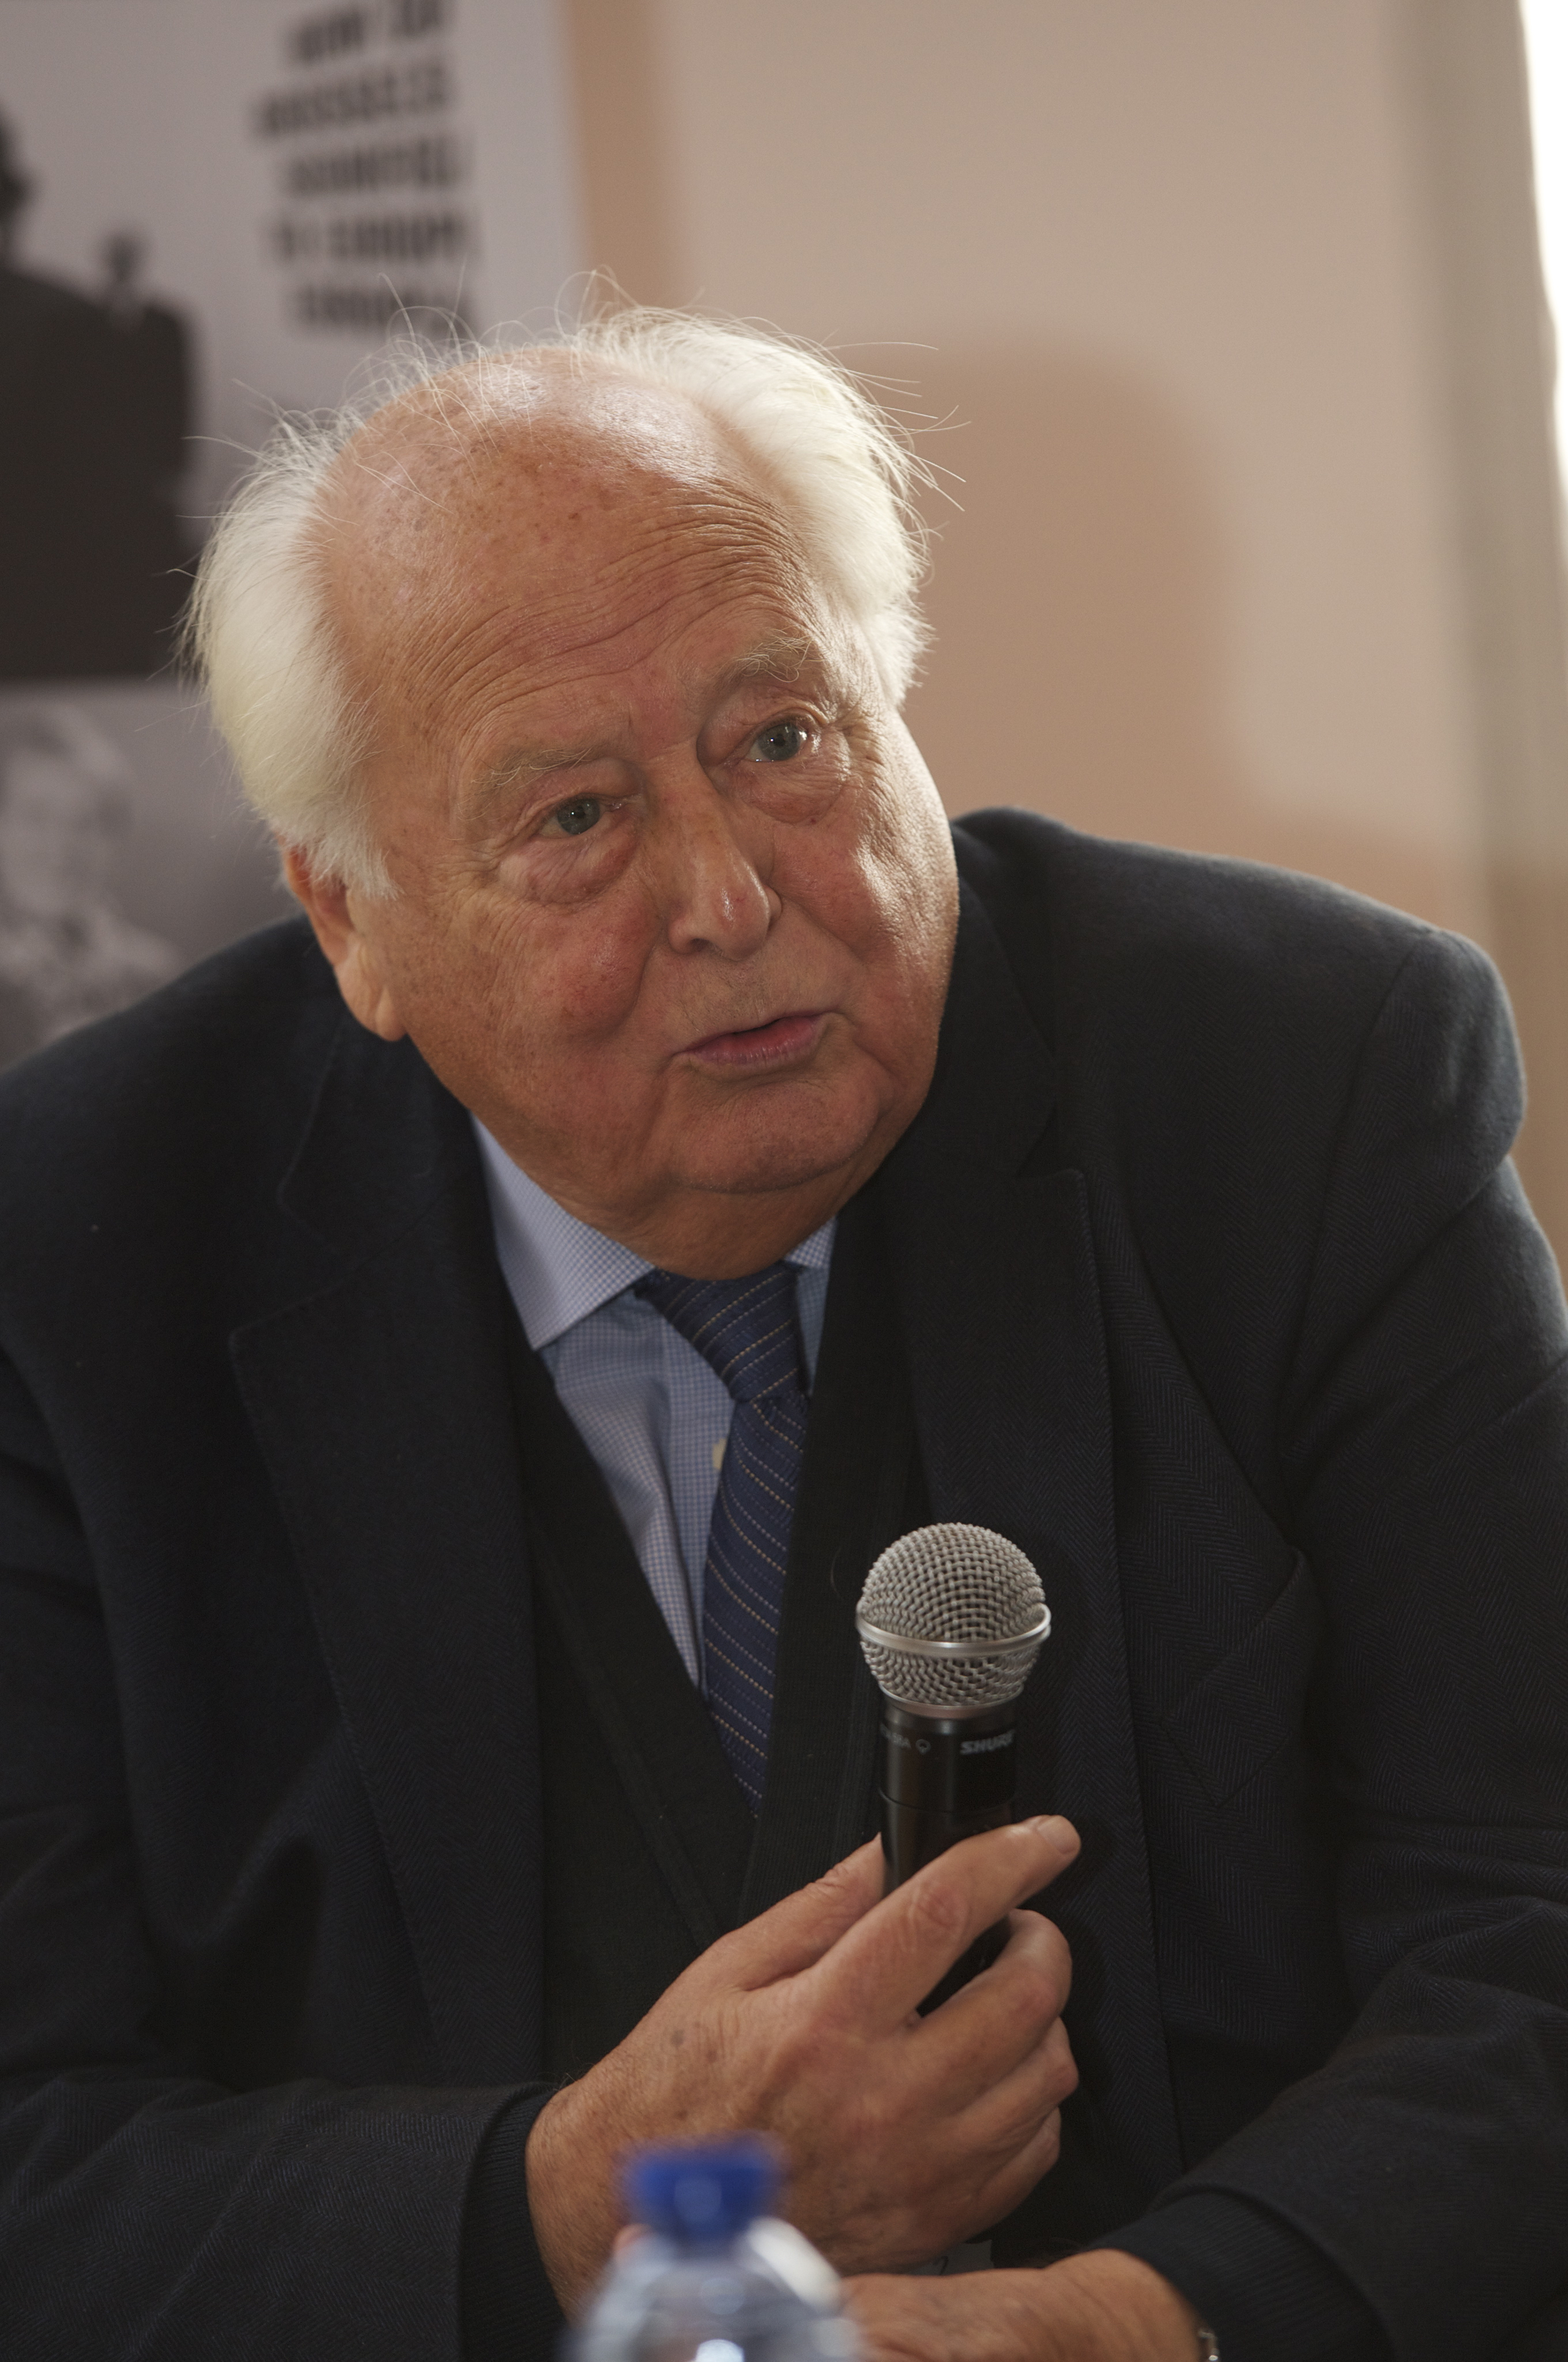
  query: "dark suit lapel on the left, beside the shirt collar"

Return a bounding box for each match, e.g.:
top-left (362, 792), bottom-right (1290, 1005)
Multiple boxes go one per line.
top-left (231, 1018), bottom-right (538, 2083)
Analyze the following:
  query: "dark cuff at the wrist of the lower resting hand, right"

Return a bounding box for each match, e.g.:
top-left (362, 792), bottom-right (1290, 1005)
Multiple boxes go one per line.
top-left (1091, 2189), bottom-right (1389, 2362)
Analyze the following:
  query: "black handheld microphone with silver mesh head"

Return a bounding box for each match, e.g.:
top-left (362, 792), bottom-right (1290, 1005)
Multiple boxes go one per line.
top-left (855, 1526), bottom-right (1051, 2013)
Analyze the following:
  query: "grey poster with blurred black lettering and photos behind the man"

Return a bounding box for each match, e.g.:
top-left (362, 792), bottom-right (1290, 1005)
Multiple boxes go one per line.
top-left (0, 0), bottom-right (581, 1063)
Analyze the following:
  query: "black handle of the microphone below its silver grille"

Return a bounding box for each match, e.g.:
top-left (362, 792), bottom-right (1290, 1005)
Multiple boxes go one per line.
top-left (881, 1696), bottom-right (1018, 2015)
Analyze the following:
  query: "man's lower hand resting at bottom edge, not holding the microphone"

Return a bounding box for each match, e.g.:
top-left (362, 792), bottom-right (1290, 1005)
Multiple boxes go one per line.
top-left (845, 2248), bottom-right (1197, 2362)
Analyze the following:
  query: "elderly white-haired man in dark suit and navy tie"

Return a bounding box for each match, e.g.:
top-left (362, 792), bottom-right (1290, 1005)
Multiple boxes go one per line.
top-left (0, 314), bottom-right (1568, 2362)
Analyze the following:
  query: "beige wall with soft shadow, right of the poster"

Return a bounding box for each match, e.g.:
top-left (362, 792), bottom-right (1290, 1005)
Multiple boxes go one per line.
top-left (571, 0), bottom-right (1568, 1242)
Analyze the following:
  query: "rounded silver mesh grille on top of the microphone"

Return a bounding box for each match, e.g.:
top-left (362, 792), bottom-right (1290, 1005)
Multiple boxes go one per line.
top-left (855, 1526), bottom-right (1051, 1715)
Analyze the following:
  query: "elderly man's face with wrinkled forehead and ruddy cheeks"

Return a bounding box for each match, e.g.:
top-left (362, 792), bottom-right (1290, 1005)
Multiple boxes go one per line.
top-left (294, 380), bottom-right (956, 1275)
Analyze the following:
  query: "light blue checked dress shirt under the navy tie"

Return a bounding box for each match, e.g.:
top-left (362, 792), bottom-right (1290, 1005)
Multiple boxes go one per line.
top-left (475, 1120), bottom-right (834, 1686)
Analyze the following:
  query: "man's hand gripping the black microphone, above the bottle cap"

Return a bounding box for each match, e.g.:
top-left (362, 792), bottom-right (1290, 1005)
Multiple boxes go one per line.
top-left (527, 1819), bottom-right (1079, 2307)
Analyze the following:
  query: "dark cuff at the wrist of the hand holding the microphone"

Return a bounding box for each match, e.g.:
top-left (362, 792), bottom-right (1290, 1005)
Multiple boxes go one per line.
top-left (460, 2085), bottom-right (567, 2362)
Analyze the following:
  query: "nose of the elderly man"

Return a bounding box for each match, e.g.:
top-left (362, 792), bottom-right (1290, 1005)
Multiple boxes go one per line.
top-left (649, 753), bottom-right (781, 959)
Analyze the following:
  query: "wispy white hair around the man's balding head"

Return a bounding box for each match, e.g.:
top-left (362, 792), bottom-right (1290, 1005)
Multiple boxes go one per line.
top-left (184, 307), bottom-right (928, 895)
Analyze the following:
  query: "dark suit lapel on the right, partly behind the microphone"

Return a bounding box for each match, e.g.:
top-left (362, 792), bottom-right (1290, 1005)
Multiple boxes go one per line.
top-left (883, 888), bottom-right (1181, 2220)
